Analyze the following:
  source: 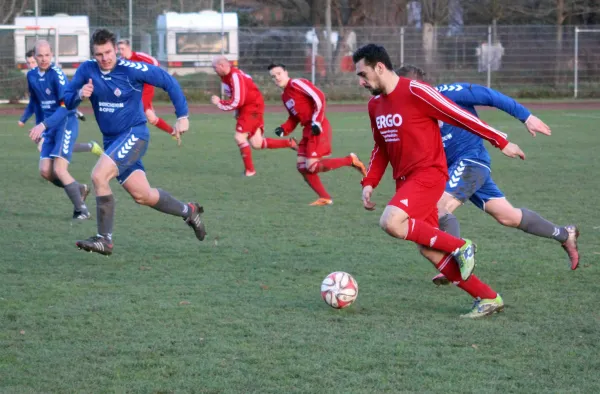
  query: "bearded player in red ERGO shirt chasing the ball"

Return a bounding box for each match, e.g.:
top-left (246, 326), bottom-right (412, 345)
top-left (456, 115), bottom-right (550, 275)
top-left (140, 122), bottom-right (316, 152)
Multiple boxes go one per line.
top-left (353, 44), bottom-right (525, 318)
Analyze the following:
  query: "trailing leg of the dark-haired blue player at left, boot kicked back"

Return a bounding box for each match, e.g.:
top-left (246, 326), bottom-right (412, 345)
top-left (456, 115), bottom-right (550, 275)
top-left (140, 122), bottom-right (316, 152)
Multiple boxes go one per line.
top-left (119, 167), bottom-right (206, 241)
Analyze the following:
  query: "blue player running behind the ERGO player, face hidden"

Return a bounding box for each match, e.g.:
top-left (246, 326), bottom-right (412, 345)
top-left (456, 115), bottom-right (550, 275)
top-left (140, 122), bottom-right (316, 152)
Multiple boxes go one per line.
top-left (396, 65), bottom-right (579, 285)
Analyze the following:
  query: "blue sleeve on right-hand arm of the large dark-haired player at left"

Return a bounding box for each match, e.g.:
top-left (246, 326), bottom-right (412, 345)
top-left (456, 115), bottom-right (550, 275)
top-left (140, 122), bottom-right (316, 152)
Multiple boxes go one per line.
top-left (126, 62), bottom-right (188, 118)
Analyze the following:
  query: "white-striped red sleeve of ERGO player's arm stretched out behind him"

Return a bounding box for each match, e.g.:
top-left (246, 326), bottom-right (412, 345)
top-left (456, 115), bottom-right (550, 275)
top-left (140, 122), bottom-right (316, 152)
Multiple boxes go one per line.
top-left (409, 81), bottom-right (508, 149)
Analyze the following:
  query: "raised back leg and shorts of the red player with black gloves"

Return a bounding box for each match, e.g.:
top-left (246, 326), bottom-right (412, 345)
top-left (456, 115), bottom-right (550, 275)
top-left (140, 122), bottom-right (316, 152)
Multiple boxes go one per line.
top-left (307, 119), bottom-right (367, 177)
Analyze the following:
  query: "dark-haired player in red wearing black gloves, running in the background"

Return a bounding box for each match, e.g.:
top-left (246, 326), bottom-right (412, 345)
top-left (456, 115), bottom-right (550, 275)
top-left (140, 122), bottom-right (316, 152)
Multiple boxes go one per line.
top-left (269, 64), bottom-right (367, 206)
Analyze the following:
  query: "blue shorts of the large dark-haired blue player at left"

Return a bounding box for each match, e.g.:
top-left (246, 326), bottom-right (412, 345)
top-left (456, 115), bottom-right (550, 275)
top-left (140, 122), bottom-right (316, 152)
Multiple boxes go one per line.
top-left (104, 124), bottom-right (149, 185)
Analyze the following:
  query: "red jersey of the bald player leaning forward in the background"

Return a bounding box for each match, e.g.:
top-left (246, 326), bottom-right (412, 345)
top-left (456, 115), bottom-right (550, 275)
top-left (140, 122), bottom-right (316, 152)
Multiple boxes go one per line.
top-left (217, 67), bottom-right (265, 111)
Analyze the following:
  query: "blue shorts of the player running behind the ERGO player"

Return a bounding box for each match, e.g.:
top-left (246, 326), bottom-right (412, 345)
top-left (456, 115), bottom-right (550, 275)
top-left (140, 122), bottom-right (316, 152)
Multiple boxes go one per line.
top-left (445, 159), bottom-right (504, 211)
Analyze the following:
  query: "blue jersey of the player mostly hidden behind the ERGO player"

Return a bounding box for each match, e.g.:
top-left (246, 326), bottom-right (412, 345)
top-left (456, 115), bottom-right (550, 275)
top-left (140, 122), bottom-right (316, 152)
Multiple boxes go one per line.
top-left (436, 83), bottom-right (531, 167)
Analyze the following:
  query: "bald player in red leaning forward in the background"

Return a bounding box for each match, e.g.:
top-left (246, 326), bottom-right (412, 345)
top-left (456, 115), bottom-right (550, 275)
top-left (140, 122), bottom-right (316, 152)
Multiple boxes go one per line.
top-left (211, 56), bottom-right (298, 176)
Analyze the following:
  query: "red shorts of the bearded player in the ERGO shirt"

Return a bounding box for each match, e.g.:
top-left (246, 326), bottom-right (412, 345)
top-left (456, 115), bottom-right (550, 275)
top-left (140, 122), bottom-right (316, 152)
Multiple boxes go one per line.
top-left (388, 168), bottom-right (446, 227)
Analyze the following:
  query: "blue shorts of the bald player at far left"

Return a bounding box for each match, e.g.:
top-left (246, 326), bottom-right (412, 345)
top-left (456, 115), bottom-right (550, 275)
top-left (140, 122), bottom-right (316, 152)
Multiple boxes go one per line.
top-left (40, 115), bottom-right (79, 163)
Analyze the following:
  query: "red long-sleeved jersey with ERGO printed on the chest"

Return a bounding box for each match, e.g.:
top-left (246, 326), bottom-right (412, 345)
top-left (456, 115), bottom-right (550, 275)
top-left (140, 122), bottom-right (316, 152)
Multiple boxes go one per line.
top-left (361, 78), bottom-right (508, 187)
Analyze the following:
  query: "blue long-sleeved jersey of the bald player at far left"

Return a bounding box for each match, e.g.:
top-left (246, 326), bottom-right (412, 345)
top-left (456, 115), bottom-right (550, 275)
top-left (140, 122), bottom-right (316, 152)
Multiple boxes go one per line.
top-left (24, 65), bottom-right (75, 129)
